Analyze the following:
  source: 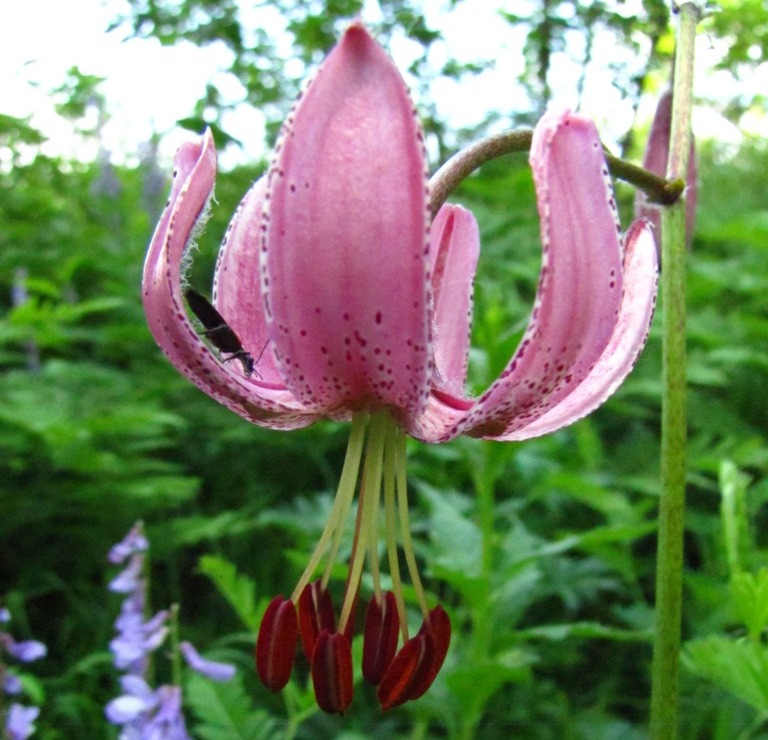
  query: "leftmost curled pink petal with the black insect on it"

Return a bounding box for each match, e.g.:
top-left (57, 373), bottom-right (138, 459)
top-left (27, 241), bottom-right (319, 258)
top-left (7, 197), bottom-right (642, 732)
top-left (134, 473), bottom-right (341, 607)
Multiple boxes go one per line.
top-left (142, 131), bottom-right (316, 429)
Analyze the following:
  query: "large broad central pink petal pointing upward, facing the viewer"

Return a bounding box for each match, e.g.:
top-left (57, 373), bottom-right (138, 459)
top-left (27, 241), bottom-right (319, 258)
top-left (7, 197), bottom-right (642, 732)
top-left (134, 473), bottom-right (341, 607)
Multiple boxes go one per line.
top-left (261, 23), bottom-right (431, 418)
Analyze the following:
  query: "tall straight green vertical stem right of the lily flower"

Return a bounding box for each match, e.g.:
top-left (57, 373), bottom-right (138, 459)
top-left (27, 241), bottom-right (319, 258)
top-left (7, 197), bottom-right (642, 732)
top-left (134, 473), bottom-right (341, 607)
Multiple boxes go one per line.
top-left (650, 3), bottom-right (701, 740)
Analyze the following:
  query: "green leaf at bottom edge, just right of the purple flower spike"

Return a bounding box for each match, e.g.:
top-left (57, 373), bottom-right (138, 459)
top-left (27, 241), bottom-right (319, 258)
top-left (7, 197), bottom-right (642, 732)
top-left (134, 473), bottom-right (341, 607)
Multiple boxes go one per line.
top-left (184, 671), bottom-right (277, 740)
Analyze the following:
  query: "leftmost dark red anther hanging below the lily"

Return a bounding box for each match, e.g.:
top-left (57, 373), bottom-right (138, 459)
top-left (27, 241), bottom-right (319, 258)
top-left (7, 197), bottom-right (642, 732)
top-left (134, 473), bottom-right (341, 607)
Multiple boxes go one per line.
top-left (256, 596), bottom-right (299, 692)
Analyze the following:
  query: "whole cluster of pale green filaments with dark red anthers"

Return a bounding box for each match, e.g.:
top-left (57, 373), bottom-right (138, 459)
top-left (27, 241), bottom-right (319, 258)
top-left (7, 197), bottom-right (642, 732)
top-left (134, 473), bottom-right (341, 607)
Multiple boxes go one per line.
top-left (256, 411), bottom-right (451, 712)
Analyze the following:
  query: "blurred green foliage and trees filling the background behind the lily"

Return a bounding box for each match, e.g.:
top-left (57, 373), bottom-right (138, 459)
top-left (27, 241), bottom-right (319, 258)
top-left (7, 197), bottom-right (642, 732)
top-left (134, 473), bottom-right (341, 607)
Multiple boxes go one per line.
top-left (0, 0), bottom-right (768, 740)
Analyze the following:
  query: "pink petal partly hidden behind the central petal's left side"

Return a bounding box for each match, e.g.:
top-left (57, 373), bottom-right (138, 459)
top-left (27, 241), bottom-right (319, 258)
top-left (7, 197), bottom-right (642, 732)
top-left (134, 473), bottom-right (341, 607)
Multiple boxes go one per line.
top-left (213, 177), bottom-right (285, 387)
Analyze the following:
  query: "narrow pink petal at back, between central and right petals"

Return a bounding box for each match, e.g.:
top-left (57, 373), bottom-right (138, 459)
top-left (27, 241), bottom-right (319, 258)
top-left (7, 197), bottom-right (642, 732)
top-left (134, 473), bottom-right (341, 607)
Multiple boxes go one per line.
top-left (430, 205), bottom-right (480, 398)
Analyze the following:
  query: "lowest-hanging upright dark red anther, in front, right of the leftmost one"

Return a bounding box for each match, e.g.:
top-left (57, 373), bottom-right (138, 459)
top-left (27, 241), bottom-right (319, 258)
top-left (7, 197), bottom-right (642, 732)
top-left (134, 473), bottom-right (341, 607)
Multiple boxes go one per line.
top-left (312, 630), bottom-right (353, 714)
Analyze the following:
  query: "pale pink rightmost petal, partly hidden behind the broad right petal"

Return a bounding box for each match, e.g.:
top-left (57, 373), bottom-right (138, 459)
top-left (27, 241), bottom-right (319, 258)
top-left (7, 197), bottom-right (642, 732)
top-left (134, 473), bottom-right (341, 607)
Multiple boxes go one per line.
top-left (492, 221), bottom-right (658, 440)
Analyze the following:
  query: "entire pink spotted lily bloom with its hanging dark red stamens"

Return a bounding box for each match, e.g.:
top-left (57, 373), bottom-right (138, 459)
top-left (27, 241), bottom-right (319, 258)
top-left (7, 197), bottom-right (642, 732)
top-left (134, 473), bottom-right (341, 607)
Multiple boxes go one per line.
top-left (143, 23), bottom-right (657, 712)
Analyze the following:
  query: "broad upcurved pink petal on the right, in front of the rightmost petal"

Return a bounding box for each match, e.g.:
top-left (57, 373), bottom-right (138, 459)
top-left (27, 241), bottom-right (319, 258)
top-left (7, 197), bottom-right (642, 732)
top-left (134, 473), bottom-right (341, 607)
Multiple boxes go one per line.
top-left (446, 112), bottom-right (623, 439)
